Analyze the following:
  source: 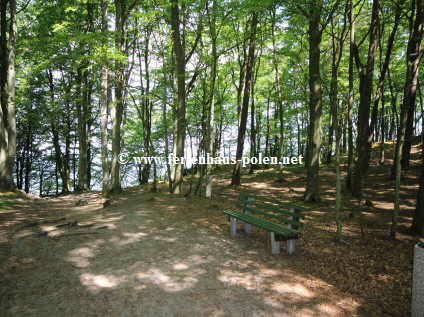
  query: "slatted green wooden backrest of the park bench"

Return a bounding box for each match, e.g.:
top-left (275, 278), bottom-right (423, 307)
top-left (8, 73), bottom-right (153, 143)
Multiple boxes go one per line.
top-left (237, 193), bottom-right (305, 230)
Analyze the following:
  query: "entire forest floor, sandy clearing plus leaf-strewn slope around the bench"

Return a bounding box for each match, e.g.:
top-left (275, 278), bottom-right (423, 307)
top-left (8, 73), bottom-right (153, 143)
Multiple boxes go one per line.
top-left (0, 144), bottom-right (422, 317)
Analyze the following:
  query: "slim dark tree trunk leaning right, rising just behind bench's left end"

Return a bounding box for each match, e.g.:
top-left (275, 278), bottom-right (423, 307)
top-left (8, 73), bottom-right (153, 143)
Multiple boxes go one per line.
top-left (231, 11), bottom-right (258, 186)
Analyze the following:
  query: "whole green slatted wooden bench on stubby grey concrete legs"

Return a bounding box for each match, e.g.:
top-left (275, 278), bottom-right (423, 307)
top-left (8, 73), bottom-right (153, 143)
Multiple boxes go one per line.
top-left (223, 193), bottom-right (305, 254)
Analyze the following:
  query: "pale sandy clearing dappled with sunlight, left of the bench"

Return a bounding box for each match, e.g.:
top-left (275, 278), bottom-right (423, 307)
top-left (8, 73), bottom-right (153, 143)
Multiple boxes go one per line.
top-left (0, 188), bottom-right (361, 317)
